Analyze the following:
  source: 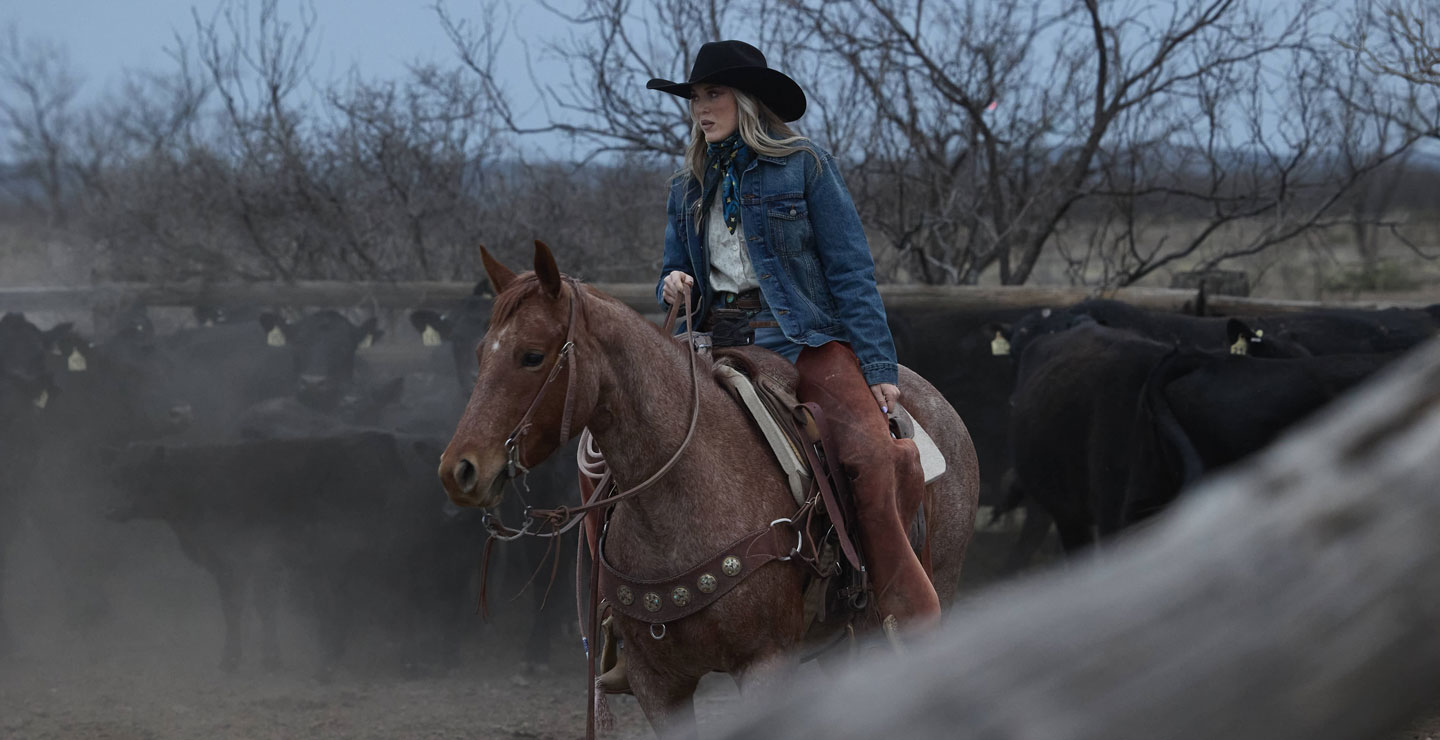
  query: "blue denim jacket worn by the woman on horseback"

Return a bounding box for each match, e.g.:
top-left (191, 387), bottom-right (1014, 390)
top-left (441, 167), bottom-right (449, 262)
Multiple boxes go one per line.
top-left (655, 144), bottom-right (899, 386)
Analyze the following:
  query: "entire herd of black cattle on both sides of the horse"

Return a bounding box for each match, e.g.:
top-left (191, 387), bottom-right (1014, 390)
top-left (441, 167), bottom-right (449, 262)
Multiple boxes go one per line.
top-left (0, 285), bottom-right (1440, 691)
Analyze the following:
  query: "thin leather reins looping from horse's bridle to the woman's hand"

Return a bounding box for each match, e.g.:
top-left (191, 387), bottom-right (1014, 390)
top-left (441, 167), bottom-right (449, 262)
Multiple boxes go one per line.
top-left (484, 278), bottom-right (700, 541)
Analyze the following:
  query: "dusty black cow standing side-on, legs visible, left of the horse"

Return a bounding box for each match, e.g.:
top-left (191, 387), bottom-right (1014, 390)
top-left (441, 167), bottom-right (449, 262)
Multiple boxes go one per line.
top-left (111, 426), bottom-right (480, 675)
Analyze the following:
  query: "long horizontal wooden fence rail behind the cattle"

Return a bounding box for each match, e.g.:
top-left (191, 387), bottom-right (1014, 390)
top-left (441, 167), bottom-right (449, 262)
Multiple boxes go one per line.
top-left (0, 281), bottom-right (1416, 314)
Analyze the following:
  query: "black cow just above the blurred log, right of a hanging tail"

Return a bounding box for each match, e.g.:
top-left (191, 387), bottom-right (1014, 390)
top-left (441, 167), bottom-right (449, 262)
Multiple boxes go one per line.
top-left (1120, 344), bottom-right (1401, 525)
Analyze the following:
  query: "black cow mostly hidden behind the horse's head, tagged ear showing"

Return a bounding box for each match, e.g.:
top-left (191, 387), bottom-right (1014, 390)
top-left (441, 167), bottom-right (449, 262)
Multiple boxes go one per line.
top-left (410, 282), bottom-right (580, 668)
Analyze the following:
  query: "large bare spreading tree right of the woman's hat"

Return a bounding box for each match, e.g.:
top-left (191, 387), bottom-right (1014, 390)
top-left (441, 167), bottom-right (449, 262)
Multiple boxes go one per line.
top-left (791, 0), bottom-right (1434, 285)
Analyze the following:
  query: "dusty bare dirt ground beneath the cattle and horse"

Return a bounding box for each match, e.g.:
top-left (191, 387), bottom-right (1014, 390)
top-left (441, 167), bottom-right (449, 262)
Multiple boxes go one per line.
top-left (0, 528), bottom-right (1440, 740)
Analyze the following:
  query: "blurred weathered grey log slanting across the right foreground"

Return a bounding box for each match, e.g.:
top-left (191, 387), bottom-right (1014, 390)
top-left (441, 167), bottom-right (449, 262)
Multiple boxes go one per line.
top-left (723, 335), bottom-right (1440, 740)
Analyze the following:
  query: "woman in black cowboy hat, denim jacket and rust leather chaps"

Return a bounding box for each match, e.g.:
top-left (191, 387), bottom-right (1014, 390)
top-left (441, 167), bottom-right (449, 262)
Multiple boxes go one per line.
top-left (647, 40), bottom-right (939, 626)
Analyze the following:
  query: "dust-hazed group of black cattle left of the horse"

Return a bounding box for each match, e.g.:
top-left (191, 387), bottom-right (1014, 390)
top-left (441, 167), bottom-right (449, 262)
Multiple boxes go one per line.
top-left (0, 283), bottom-right (577, 677)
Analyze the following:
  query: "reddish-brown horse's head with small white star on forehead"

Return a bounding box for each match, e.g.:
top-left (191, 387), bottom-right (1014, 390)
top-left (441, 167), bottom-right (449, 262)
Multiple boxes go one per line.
top-left (439, 242), bottom-right (596, 508)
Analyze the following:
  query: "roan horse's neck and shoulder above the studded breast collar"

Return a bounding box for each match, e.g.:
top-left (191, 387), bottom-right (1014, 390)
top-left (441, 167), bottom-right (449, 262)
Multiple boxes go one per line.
top-left (589, 293), bottom-right (793, 558)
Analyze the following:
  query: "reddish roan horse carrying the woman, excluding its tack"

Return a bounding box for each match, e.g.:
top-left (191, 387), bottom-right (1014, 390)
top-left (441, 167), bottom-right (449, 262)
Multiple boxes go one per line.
top-left (439, 242), bottom-right (979, 737)
